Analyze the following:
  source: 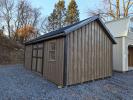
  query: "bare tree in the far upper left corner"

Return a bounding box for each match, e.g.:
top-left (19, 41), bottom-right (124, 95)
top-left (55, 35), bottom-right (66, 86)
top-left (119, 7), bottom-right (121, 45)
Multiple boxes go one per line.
top-left (0, 0), bottom-right (14, 37)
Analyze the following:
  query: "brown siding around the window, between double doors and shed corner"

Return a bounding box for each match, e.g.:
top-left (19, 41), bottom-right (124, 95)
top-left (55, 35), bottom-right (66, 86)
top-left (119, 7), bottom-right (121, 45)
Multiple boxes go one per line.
top-left (43, 38), bottom-right (64, 85)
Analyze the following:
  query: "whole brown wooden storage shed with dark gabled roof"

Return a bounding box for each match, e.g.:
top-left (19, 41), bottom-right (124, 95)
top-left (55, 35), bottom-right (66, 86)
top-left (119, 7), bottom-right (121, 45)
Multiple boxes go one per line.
top-left (25, 16), bottom-right (116, 86)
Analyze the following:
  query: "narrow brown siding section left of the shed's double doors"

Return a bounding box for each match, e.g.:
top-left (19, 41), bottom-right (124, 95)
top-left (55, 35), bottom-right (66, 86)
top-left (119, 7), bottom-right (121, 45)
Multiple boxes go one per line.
top-left (24, 45), bottom-right (32, 69)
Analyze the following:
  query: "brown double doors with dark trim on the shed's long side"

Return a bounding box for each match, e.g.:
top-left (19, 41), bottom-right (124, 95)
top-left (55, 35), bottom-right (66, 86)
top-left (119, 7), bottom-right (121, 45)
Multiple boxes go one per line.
top-left (32, 43), bottom-right (43, 73)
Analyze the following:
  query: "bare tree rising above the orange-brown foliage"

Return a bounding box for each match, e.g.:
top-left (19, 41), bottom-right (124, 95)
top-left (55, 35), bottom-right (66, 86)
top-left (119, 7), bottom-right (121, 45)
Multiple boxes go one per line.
top-left (14, 0), bottom-right (41, 41)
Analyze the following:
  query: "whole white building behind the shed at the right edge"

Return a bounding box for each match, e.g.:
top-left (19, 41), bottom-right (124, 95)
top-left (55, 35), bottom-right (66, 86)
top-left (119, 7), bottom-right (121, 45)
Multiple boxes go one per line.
top-left (106, 17), bottom-right (133, 71)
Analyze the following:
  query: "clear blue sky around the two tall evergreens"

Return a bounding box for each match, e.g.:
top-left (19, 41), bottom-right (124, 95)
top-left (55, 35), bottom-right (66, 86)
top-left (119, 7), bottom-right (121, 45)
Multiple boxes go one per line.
top-left (31, 0), bottom-right (102, 20)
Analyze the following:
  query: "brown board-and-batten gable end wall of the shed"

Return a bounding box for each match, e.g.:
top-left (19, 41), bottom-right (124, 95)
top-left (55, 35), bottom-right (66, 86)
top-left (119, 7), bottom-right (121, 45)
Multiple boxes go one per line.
top-left (66, 21), bottom-right (113, 85)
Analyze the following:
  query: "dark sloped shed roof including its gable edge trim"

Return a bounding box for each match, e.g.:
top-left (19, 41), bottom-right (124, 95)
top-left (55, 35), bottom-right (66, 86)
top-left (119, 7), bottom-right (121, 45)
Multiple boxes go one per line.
top-left (25, 15), bottom-right (115, 44)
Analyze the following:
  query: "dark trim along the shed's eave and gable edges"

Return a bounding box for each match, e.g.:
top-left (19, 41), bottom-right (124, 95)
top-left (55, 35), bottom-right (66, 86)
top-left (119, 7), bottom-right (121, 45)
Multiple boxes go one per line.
top-left (25, 16), bottom-right (116, 45)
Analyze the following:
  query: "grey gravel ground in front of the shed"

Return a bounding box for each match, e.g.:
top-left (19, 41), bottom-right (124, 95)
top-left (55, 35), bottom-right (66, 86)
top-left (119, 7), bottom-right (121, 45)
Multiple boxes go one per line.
top-left (0, 65), bottom-right (133, 100)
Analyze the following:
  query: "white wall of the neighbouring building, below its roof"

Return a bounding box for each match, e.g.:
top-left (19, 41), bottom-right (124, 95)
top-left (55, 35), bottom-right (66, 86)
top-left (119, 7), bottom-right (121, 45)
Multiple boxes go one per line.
top-left (113, 33), bottom-right (133, 72)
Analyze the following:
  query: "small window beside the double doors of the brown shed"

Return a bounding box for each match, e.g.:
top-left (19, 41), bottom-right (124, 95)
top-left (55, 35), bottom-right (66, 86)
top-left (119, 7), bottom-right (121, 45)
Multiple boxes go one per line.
top-left (49, 42), bottom-right (56, 61)
